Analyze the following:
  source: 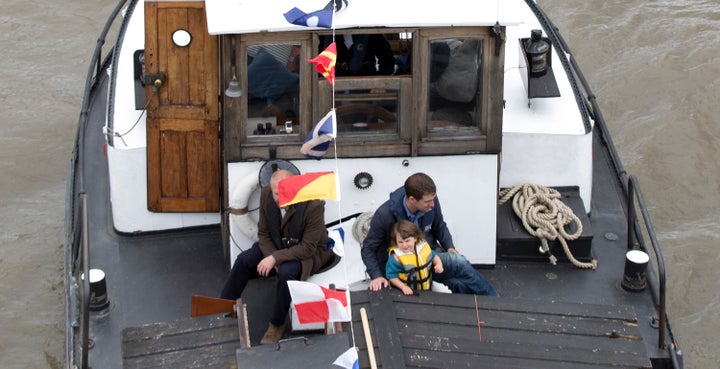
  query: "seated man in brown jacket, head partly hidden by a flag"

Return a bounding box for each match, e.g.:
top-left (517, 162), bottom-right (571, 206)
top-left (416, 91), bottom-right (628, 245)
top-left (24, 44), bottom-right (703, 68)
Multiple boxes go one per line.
top-left (220, 169), bottom-right (333, 345)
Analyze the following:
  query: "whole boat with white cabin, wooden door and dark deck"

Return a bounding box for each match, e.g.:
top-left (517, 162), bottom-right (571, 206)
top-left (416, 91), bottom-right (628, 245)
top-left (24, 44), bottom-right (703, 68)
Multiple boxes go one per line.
top-left (64, 0), bottom-right (683, 369)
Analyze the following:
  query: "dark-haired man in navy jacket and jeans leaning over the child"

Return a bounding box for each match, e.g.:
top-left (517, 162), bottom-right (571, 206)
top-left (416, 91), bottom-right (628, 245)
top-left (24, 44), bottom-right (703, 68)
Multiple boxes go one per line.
top-left (360, 173), bottom-right (498, 296)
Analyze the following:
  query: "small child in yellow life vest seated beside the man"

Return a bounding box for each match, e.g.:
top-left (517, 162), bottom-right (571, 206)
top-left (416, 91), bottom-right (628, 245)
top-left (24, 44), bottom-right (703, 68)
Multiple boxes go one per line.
top-left (385, 220), bottom-right (443, 295)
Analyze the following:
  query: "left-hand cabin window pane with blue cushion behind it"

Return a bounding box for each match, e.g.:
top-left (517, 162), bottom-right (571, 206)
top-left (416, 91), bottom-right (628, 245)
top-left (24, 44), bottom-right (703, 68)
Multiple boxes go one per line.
top-left (247, 43), bottom-right (300, 136)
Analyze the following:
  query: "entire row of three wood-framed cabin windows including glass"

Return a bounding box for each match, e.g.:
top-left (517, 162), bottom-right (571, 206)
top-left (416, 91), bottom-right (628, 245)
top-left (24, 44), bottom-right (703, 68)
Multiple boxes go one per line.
top-left (224, 27), bottom-right (504, 161)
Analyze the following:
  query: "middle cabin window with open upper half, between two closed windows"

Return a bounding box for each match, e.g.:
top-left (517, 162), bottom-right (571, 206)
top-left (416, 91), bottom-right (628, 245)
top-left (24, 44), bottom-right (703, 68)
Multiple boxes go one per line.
top-left (318, 31), bottom-right (412, 145)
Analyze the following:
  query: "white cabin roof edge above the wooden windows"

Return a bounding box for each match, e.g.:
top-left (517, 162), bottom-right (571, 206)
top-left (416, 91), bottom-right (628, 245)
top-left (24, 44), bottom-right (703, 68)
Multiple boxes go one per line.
top-left (205, 0), bottom-right (526, 35)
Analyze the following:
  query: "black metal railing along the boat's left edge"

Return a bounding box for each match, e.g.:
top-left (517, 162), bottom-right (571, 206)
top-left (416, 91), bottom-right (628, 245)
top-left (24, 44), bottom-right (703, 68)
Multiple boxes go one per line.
top-left (64, 0), bottom-right (131, 368)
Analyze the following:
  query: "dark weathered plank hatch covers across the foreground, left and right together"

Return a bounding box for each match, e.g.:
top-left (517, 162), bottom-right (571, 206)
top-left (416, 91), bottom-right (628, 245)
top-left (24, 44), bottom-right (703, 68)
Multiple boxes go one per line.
top-left (123, 289), bottom-right (652, 369)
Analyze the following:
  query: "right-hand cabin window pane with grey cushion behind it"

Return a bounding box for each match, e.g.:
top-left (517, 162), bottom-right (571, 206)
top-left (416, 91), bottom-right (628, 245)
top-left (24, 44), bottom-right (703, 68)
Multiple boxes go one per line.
top-left (427, 38), bottom-right (483, 134)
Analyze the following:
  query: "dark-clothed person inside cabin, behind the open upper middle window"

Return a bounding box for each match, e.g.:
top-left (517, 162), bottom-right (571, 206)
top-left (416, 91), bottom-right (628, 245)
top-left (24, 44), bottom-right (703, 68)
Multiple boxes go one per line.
top-left (320, 34), bottom-right (395, 77)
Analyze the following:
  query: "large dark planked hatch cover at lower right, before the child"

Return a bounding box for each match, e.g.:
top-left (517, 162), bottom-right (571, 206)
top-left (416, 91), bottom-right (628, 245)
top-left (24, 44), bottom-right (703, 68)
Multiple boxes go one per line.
top-left (351, 290), bottom-right (652, 368)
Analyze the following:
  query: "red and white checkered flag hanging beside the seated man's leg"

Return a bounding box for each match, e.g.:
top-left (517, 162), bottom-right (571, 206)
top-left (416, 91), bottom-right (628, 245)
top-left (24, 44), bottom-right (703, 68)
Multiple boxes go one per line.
top-left (288, 281), bottom-right (350, 324)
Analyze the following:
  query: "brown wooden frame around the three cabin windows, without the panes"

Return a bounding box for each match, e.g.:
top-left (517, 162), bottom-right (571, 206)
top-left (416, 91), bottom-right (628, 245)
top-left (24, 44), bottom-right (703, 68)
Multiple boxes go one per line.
top-left (222, 27), bottom-right (505, 162)
